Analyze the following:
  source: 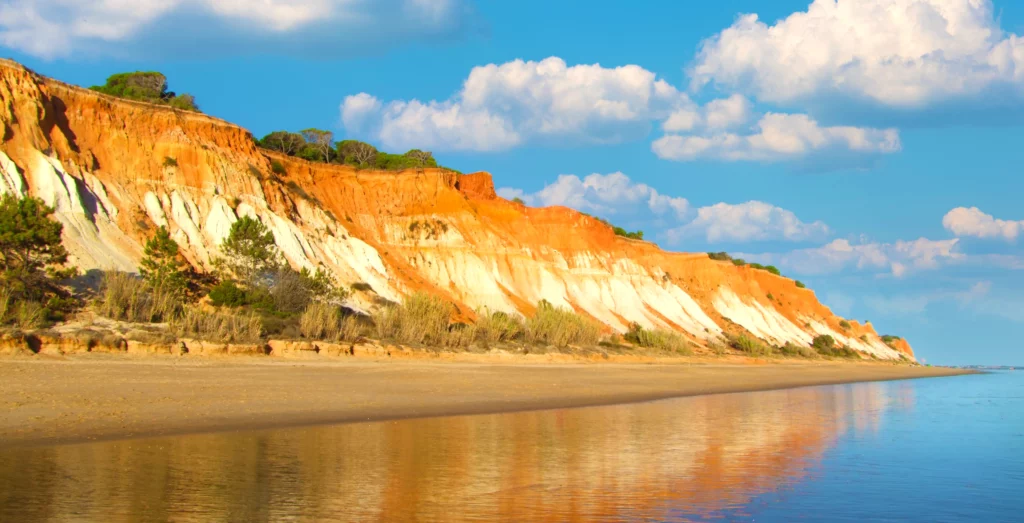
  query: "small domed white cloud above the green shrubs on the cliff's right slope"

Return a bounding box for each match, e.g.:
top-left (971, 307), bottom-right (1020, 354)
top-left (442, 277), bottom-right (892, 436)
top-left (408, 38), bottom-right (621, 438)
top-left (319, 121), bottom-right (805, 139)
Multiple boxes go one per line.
top-left (668, 202), bottom-right (829, 243)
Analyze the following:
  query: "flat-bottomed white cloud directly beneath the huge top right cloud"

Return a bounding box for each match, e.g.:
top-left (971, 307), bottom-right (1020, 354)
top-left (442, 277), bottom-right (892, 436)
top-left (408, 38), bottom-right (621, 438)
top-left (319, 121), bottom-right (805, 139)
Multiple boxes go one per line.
top-left (651, 113), bottom-right (901, 162)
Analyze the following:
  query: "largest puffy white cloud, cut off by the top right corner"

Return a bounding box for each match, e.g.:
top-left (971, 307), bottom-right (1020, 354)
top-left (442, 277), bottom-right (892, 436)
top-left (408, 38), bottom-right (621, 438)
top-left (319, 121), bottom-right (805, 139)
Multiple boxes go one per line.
top-left (690, 0), bottom-right (1024, 108)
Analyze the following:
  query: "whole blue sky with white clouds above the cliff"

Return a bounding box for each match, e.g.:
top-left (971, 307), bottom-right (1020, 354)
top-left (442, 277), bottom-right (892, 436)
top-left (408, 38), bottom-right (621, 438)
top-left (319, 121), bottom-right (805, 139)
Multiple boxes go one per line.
top-left (0, 0), bottom-right (1024, 364)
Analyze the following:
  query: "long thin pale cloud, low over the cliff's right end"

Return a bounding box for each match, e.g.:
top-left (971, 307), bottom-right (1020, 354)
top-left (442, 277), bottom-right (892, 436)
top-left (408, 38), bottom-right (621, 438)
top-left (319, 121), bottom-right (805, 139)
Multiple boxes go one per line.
top-left (744, 237), bottom-right (965, 277)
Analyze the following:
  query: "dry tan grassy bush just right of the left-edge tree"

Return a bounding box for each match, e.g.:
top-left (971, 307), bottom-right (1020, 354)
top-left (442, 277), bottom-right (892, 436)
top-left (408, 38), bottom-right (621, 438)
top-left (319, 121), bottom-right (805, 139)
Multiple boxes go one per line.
top-left (94, 271), bottom-right (181, 323)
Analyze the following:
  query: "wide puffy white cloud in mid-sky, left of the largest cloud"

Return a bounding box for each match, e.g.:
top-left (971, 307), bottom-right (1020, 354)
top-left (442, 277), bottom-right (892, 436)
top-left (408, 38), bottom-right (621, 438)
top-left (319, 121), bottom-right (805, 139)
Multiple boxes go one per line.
top-left (342, 56), bottom-right (691, 150)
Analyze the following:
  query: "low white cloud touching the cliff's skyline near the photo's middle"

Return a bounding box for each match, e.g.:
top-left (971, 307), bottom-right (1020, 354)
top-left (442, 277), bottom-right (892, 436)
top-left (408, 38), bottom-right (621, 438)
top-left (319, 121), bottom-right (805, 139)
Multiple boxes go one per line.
top-left (498, 172), bottom-right (689, 218)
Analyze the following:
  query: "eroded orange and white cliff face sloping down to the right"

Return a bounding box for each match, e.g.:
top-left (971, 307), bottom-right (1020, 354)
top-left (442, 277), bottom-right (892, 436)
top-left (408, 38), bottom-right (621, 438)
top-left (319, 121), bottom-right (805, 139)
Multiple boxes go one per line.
top-left (0, 61), bottom-right (912, 359)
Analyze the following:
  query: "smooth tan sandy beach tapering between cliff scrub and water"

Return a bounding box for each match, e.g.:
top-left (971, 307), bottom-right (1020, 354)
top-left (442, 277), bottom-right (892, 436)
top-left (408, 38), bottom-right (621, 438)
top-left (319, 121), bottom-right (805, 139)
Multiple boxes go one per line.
top-left (0, 355), bottom-right (980, 449)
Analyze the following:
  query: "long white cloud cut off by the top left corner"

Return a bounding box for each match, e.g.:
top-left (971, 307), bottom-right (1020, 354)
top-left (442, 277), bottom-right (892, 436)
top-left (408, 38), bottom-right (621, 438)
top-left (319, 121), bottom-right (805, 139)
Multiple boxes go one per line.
top-left (0, 0), bottom-right (473, 58)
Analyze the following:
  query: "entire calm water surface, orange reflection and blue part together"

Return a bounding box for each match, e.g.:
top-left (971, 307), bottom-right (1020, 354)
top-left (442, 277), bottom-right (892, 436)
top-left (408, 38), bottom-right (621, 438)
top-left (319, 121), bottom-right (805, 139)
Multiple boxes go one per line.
top-left (0, 372), bottom-right (1024, 522)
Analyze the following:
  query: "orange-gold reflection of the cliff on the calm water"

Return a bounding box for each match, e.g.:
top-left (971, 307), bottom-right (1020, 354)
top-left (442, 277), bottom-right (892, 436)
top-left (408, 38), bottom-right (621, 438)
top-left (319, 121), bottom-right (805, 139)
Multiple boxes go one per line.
top-left (0, 385), bottom-right (913, 522)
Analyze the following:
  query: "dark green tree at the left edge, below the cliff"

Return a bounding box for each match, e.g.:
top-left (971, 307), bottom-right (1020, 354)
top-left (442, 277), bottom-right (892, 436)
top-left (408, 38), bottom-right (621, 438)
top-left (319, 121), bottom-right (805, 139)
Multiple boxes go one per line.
top-left (0, 193), bottom-right (77, 313)
